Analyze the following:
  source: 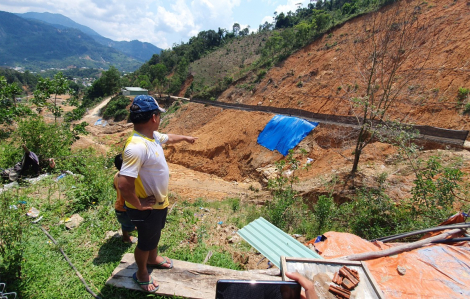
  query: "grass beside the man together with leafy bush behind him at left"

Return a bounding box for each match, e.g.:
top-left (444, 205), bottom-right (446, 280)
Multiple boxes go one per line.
top-left (0, 154), bottom-right (246, 298)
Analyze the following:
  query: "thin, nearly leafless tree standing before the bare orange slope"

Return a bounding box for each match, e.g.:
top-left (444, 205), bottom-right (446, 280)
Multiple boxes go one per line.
top-left (340, 1), bottom-right (435, 176)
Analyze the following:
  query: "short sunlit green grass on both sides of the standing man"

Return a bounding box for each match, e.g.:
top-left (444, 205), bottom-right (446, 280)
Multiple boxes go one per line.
top-left (0, 167), bottom-right (260, 298)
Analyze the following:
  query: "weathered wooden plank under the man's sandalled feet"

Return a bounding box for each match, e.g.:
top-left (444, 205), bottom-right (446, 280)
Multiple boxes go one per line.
top-left (106, 253), bottom-right (281, 299)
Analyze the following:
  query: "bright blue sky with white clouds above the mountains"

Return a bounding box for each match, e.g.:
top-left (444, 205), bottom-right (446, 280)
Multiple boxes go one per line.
top-left (0, 0), bottom-right (314, 49)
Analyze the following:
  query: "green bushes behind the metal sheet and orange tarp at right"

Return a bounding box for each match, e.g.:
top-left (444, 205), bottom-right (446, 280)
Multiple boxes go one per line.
top-left (261, 151), bottom-right (470, 240)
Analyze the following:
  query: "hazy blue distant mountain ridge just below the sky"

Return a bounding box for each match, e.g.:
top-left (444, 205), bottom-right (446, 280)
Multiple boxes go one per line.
top-left (16, 12), bottom-right (162, 62)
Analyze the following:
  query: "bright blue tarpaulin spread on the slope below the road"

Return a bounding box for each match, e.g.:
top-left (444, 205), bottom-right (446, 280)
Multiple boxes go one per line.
top-left (258, 115), bottom-right (318, 156)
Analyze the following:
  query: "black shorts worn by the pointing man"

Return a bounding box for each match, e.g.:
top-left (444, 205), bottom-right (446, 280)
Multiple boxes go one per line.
top-left (126, 207), bottom-right (168, 251)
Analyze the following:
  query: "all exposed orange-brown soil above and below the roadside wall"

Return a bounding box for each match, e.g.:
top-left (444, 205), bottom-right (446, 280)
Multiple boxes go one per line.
top-left (77, 0), bottom-right (470, 201)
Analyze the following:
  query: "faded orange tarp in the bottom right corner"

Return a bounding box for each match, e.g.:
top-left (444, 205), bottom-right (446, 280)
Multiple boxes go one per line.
top-left (314, 232), bottom-right (470, 298)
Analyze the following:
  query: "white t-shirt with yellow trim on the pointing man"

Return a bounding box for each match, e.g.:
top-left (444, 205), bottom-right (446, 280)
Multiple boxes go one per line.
top-left (120, 131), bottom-right (170, 209)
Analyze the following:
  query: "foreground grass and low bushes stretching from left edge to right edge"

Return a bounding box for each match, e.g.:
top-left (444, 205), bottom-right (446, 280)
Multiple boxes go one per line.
top-left (0, 146), bottom-right (469, 298)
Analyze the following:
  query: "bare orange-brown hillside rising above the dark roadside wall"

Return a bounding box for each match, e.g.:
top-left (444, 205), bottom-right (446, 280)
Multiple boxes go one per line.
top-left (212, 0), bottom-right (470, 130)
